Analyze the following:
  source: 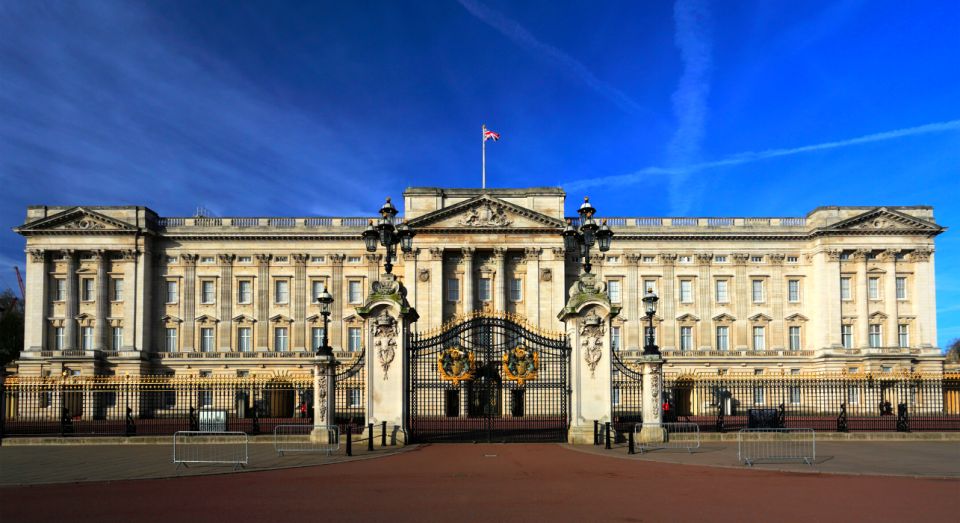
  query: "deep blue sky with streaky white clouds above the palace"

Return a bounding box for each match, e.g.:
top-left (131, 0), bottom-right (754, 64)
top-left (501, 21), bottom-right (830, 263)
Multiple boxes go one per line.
top-left (0, 0), bottom-right (960, 345)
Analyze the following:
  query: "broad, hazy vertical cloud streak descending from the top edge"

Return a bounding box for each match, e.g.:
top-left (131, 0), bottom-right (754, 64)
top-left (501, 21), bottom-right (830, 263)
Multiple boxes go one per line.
top-left (667, 0), bottom-right (713, 214)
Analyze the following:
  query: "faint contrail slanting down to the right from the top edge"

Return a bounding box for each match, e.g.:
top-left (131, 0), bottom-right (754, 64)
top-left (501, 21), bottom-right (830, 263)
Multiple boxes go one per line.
top-left (458, 0), bottom-right (645, 114)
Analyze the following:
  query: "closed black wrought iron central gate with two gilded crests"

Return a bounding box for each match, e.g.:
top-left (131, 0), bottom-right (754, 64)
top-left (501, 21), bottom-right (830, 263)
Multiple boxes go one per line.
top-left (407, 314), bottom-right (570, 442)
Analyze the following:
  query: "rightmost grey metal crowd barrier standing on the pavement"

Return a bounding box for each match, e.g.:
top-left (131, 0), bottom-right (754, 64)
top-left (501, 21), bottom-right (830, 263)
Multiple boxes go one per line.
top-left (737, 429), bottom-right (817, 466)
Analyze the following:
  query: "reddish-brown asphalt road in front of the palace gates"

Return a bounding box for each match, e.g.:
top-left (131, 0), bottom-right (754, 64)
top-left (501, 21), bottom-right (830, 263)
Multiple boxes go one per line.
top-left (0, 444), bottom-right (960, 523)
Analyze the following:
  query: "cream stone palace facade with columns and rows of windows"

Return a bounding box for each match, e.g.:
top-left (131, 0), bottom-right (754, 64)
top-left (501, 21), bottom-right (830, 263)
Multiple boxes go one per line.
top-left (15, 188), bottom-right (944, 377)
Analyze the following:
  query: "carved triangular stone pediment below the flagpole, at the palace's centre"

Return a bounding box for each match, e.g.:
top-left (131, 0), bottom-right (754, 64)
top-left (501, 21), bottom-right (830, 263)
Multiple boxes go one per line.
top-left (407, 194), bottom-right (564, 231)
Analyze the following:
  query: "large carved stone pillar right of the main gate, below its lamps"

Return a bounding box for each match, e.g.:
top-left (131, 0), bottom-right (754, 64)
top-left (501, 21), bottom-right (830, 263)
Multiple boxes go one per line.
top-left (557, 273), bottom-right (620, 444)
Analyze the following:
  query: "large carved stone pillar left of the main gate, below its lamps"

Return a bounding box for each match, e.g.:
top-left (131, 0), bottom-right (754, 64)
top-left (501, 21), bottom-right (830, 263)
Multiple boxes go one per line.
top-left (357, 274), bottom-right (418, 438)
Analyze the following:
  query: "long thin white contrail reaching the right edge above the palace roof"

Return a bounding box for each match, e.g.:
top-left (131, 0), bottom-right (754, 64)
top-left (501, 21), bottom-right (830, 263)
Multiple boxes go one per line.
top-left (563, 120), bottom-right (960, 191)
